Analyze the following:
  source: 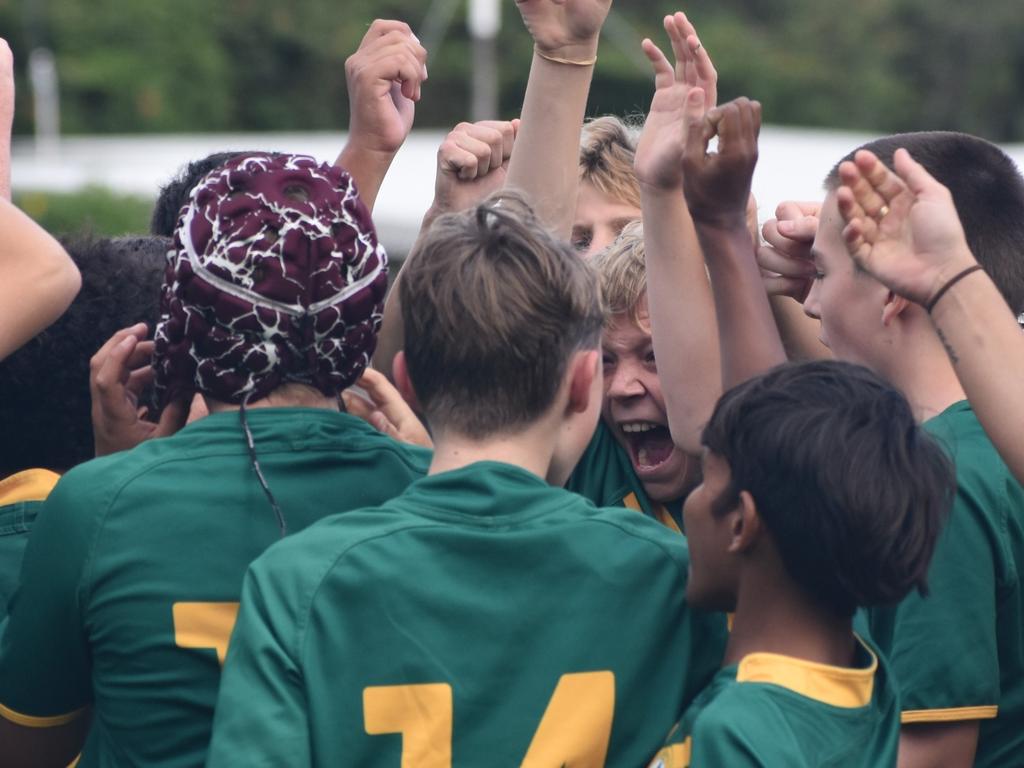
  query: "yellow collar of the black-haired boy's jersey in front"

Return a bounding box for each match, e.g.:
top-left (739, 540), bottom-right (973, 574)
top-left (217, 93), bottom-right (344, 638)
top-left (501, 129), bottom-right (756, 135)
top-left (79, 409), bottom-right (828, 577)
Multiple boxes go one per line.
top-left (736, 637), bottom-right (879, 709)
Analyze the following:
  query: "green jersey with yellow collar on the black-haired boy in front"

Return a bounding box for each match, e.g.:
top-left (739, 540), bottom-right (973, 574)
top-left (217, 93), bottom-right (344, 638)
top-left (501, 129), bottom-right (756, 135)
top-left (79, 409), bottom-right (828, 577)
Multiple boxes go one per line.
top-left (649, 643), bottom-right (899, 768)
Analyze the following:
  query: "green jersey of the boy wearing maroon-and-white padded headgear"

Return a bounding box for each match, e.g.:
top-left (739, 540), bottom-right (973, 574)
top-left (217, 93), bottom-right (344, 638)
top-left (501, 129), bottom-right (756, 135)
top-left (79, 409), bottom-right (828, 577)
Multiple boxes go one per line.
top-left (0, 408), bottom-right (430, 768)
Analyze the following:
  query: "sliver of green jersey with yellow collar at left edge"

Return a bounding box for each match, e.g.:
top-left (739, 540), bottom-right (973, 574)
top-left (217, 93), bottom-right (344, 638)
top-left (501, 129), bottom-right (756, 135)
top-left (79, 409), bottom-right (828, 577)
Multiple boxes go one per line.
top-left (0, 469), bottom-right (60, 623)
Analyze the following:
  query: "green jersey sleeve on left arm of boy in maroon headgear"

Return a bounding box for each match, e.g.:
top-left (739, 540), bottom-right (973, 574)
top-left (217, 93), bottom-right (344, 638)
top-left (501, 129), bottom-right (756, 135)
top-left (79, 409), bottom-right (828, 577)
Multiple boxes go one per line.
top-left (0, 474), bottom-right (96, 728)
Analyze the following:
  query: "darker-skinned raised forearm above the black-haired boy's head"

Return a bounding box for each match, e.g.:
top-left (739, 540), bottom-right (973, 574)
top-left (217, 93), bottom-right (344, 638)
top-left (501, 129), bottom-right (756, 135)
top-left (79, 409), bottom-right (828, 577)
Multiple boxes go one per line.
top-left (696, 220), bottom-right (786, 389)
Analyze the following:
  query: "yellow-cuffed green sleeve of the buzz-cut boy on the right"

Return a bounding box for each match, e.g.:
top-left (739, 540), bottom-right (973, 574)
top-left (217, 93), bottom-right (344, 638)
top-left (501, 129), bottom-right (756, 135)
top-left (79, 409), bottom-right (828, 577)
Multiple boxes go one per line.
top-left (869, 487), bottom-right (999, 723)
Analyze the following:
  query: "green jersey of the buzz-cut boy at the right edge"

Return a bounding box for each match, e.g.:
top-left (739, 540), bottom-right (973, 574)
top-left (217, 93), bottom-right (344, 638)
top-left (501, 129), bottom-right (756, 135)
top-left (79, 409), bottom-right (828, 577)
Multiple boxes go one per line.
top-left (867, 400), bottom-right (1024, 767)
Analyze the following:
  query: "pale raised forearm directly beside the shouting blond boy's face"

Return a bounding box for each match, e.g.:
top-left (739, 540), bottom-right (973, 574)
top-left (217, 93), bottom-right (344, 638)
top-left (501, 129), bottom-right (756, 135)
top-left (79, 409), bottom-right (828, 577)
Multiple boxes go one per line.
top-left (641, 187), bottom-right (722, 454)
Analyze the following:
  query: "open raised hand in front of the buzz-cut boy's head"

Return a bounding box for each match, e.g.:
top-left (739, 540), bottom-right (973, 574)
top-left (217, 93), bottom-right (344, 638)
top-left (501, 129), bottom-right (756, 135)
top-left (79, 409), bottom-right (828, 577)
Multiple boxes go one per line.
top-left (837, 150), bottom-right (976, 305)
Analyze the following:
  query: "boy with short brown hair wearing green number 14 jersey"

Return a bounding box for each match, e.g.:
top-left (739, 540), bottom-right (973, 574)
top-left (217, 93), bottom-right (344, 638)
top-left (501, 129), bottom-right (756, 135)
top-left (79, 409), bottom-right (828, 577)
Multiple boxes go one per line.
top-left (203, 197), bottom-right (725, 768)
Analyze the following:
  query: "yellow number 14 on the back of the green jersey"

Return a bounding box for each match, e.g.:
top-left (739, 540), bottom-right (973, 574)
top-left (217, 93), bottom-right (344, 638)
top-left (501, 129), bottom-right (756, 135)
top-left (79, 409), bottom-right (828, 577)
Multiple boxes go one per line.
top-left (362, 671), bottom-right (615, 768)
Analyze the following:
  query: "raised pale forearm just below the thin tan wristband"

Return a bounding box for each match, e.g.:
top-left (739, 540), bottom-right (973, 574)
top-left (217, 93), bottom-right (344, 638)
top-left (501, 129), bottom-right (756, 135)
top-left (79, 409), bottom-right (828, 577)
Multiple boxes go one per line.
top-left (506, 51), bottom-right (597, 239)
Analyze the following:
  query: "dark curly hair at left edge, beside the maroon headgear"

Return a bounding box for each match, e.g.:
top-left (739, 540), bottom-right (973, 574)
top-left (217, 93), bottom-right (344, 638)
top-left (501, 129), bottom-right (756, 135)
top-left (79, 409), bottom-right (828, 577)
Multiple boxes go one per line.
top-left (0, 236), bottom-right (171, 477)
